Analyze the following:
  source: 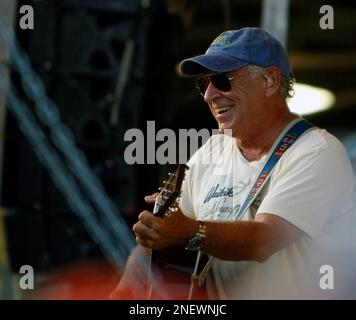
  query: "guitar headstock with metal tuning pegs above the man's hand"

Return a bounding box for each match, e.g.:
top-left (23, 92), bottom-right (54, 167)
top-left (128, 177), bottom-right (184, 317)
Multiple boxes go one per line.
top-left (153, 164), bottom-right (189, 217)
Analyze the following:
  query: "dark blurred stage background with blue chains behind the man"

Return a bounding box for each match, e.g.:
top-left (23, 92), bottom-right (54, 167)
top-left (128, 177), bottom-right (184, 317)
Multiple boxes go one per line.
top-left (0, 0), bottom-right (356, 299)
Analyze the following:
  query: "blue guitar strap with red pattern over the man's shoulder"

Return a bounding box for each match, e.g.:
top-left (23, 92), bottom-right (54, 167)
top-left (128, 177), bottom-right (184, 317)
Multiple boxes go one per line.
top-left (191, 118), bottom-right (315, 292)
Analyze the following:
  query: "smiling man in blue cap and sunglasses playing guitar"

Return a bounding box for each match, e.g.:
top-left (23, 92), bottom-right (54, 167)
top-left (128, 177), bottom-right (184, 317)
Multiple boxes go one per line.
top-left (113, 28), bottom-right (355, 299)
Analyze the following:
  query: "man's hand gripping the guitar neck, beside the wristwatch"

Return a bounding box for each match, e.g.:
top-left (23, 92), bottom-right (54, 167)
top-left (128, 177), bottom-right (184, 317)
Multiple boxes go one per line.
top-left (133, 193), bottom-right (199, 249)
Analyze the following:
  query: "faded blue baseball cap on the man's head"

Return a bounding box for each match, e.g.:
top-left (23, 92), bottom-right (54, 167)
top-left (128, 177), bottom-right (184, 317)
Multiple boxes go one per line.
top-left (179, 27), bottom-right (293, 78)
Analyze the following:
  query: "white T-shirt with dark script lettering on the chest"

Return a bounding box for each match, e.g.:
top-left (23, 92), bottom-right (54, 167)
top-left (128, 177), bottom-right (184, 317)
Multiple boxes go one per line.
top-left (180, 129), bottom-right (356, 299)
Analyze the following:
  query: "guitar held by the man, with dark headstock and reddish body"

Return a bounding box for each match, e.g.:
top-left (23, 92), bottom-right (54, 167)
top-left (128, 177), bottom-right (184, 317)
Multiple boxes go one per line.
top-left (147, 165), bottom-right (208, 300)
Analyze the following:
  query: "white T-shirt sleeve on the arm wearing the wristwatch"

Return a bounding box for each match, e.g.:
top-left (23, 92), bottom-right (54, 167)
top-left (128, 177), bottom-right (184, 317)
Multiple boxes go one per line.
top-left (257, 138), bottom-right (353, 238)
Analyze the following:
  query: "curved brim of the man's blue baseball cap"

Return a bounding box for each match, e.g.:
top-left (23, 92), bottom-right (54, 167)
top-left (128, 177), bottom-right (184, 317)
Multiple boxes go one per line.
top-left (179, 54), bottom-right (248, 76)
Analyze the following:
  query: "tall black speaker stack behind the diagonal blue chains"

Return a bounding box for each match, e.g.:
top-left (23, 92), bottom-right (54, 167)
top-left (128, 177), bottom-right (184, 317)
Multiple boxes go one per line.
top-left (1, 0), bottom-right (166, 271)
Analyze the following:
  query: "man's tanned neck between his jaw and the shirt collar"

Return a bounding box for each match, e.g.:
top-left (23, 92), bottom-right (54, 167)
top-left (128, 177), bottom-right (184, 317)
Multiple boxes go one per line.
top-left (235, 113), bottom-right (297, 161)
